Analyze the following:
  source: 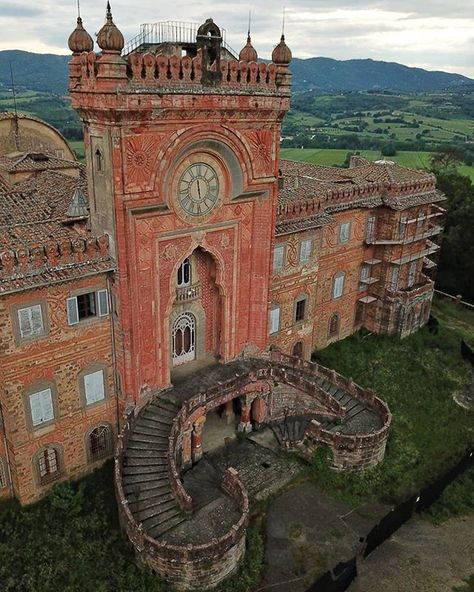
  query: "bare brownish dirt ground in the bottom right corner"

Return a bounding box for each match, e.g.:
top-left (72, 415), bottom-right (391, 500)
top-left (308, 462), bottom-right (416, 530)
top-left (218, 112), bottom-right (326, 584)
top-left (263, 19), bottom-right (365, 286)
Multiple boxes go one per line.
top-left (349, 516), bottom-right (474, 592)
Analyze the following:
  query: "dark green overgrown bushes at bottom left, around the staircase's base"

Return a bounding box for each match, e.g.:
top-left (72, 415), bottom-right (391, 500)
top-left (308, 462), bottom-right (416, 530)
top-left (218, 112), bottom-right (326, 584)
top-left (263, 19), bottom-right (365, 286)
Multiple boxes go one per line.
top-left (0, 463), bottom-right (264, 592)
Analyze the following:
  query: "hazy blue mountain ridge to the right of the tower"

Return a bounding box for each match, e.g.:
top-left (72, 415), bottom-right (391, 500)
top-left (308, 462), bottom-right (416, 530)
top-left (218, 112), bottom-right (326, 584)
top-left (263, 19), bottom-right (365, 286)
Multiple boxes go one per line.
top-left (290, 58), bottom-right (474, 93)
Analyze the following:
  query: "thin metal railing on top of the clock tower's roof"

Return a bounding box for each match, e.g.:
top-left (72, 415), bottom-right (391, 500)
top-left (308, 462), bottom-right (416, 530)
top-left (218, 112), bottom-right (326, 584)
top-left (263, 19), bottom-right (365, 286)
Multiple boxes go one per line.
top-left (123, 21), bottom-right (238, 59)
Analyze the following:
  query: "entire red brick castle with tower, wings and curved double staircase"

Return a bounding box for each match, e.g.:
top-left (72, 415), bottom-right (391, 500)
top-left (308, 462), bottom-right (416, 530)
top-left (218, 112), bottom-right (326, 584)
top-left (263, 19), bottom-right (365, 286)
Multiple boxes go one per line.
top-left (0, 6), bottom-right (444, 589)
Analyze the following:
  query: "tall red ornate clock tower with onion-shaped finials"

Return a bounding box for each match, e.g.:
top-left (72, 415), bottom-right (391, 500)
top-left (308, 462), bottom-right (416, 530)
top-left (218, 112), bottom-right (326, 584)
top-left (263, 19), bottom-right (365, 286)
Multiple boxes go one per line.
top-left (69, 6), bottom-right (291, 402)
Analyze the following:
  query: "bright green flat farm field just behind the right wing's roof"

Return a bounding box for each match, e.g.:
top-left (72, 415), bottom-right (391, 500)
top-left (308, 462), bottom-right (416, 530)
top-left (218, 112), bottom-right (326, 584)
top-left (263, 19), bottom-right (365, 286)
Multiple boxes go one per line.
top-left (280, 148), bottom-right (474, 181)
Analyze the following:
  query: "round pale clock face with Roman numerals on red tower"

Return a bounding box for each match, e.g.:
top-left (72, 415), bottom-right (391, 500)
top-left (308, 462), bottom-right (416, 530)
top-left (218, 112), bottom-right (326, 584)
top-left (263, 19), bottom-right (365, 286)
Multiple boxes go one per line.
top-left (178, 162), bottom-right (219, 216)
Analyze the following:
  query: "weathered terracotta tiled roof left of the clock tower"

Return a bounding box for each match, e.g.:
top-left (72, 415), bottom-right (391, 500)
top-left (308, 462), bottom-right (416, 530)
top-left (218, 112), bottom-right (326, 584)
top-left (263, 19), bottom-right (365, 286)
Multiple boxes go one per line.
top-left (0, 170), bottom-right (115, 294)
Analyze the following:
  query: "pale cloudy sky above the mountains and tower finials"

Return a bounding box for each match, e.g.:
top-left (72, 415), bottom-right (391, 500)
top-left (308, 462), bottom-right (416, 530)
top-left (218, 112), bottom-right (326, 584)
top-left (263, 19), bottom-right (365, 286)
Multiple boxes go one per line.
top-left (0, 0), bottom-right (474, 78)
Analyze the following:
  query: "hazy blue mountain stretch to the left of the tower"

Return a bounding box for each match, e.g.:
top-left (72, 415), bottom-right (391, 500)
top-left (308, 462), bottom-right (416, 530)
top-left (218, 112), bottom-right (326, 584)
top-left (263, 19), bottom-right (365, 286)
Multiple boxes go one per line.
top-left (0, 49), bottom-right (70, 95)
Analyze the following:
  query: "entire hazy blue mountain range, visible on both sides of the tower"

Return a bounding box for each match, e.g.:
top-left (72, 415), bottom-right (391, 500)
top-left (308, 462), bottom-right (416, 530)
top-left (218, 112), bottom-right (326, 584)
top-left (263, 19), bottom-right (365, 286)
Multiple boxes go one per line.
top-left (0, 50), bottom-right (474, 94)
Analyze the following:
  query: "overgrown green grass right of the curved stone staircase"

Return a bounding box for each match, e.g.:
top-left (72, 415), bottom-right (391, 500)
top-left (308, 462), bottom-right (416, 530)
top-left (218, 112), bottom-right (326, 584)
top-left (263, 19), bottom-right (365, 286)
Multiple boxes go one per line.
top-left (313, 300), bottom-right (474, 504)
